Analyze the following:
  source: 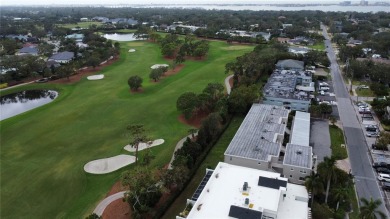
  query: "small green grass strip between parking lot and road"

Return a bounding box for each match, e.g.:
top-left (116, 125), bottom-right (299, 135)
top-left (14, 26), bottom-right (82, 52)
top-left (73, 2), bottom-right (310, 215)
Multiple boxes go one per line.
top-left (329, 125), bottom-right (348, 160)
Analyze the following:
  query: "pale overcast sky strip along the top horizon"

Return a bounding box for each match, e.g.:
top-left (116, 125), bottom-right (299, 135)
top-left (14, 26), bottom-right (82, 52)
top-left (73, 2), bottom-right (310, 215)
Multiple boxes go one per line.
top-left (0, 0), bottom-right (364, 6)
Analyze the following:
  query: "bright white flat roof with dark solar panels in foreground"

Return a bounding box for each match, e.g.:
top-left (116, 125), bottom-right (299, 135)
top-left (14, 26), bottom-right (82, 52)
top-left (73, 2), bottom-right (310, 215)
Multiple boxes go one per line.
top-left (187, 162), bottom-right (308, 219)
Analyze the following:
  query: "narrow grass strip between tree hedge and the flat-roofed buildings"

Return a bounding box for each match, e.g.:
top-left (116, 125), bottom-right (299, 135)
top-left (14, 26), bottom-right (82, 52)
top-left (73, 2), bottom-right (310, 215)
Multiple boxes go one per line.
top-left (163, 116), bottom-right (244, 219)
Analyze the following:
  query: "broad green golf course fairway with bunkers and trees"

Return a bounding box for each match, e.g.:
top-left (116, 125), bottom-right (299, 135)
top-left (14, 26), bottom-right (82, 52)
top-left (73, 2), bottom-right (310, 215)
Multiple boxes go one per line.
top-left (0, 42), bottom-right (253, 218)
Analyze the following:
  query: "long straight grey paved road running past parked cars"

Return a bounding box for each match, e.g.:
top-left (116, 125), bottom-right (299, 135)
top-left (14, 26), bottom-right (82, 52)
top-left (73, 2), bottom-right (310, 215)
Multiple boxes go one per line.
top-left (321, 26), bottom-right (389, 218)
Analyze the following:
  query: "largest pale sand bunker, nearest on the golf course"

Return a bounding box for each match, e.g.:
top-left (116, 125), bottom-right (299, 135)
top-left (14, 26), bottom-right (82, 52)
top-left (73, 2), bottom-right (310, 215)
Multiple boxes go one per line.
top-left (84, 154), bottom-right (135, 174)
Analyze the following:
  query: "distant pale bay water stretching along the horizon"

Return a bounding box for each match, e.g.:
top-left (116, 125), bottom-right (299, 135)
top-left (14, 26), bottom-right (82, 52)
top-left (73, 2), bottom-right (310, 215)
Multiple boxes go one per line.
top-left (130, 4), bottom-right (390, 13)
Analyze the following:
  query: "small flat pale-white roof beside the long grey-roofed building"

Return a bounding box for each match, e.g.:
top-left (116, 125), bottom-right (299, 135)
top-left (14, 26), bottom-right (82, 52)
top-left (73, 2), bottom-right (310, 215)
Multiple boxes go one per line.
top-left (291, 111), bottom-right (310, 146)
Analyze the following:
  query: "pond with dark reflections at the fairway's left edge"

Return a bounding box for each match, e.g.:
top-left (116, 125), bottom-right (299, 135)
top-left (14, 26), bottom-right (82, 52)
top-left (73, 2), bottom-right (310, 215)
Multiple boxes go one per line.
top-left (0, 90), bottom-right (58, 121)
